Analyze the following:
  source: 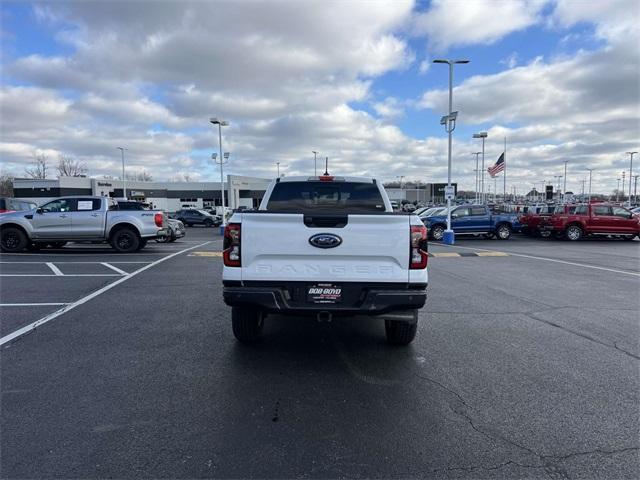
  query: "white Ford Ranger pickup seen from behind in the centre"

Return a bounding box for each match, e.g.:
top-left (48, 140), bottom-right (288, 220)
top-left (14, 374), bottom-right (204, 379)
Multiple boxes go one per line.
top-left (222, 175), bottom-right (428, 345)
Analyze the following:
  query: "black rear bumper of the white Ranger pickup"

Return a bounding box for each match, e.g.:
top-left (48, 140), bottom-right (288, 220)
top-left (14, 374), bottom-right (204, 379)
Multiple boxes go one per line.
top-left (223, 282), bottom-right (427, 316)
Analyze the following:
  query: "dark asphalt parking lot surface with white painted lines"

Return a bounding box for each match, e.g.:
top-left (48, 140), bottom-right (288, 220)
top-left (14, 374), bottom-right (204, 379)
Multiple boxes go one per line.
top-left (0, 228), bottom-right (640, 479)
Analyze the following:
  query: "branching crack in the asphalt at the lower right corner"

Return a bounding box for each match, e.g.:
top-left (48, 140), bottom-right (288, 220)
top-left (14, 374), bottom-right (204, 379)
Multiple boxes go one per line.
top-left (414, 372), bottom-right (640, 480)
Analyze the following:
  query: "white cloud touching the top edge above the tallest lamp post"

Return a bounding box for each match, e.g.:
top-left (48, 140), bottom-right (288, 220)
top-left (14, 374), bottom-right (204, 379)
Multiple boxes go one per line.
top-left (413, 0), bottom-right (547, 51)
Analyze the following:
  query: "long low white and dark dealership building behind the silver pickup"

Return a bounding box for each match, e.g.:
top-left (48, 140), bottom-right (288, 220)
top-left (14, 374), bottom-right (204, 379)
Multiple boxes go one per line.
top-left (13, 175), bottom-right (271, 212)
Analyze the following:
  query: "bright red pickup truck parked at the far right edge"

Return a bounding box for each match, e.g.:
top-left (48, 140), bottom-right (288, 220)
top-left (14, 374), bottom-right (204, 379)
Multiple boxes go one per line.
top-left (541, 203), bottom-right (640, 241)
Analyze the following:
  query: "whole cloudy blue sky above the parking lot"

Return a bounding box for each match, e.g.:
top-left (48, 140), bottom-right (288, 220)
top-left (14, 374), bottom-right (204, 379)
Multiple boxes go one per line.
top-left (0, 0), bottom-right (640, 192)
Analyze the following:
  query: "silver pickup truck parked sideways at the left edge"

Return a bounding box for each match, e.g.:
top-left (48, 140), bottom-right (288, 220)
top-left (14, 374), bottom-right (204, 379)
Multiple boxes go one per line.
top-left (0, 197), bottom-right (168, 253)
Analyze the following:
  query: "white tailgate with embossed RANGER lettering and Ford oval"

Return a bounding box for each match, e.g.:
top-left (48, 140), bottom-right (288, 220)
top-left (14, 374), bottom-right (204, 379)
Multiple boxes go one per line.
top-left (241, 212), bottom-right (410, 283)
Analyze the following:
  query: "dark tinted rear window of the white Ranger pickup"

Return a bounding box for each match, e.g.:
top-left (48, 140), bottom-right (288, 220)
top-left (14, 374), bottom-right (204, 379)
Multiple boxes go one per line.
top-left (267, 181), bottom-right (385, 213)
